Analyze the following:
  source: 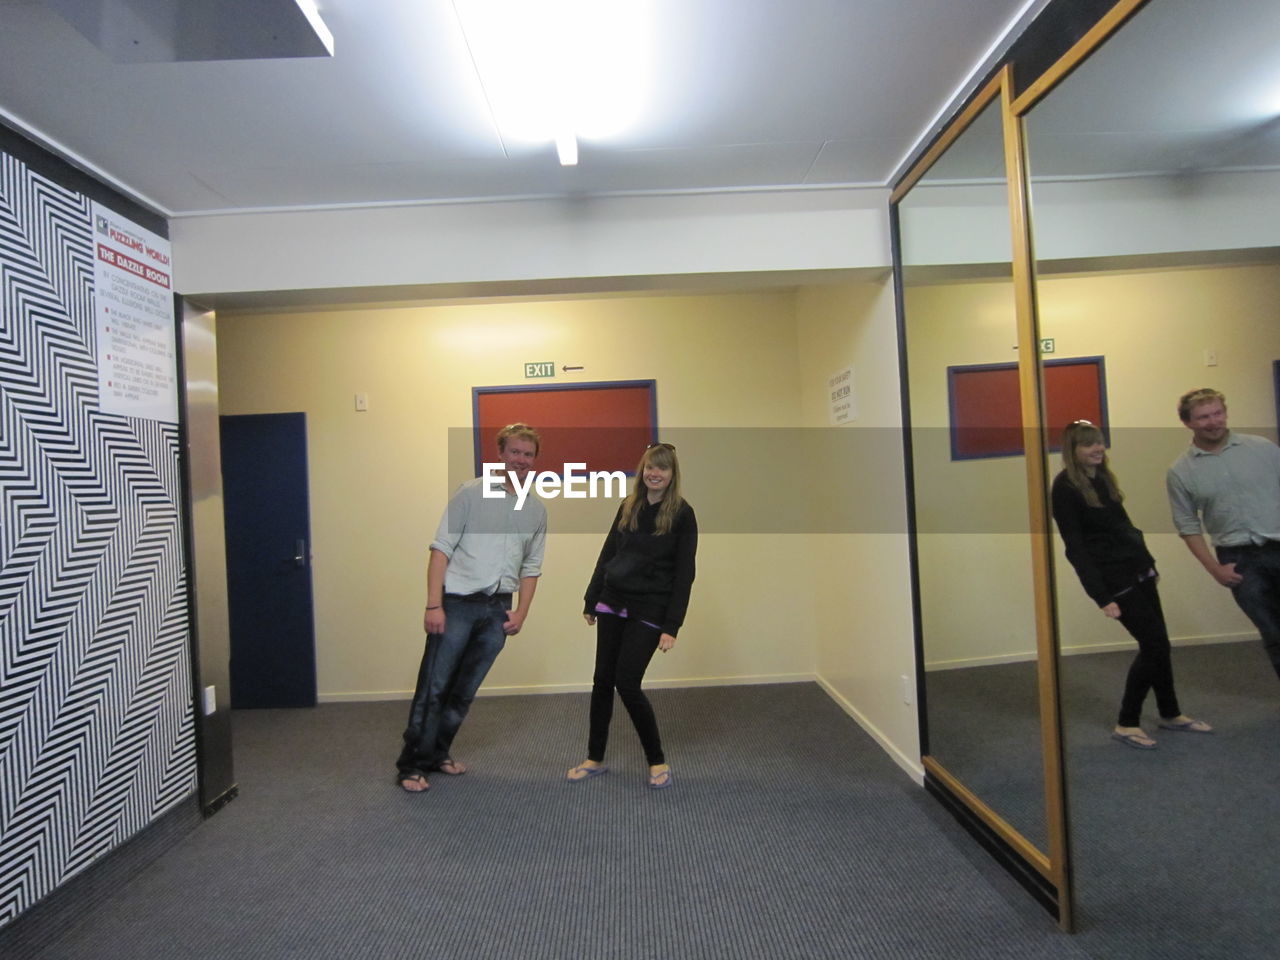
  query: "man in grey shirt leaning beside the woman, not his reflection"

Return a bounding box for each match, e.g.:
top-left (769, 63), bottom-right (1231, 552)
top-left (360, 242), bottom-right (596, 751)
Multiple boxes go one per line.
top-left (396, 424), bottom-right (547, 794)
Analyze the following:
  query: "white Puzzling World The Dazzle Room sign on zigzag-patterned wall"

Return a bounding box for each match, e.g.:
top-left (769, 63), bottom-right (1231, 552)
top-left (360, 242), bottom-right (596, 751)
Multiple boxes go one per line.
top-left (93, 202), bottom-right (178, 422)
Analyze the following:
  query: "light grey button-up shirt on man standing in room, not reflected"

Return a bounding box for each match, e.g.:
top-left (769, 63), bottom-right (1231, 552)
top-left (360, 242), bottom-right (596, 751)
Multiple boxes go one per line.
top-left (431, 477), bottom-right (547, 594)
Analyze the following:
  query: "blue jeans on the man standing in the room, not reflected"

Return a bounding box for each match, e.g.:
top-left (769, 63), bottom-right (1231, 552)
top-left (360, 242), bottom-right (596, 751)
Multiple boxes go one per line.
top-left (396, 594), bottom-right (511, 776)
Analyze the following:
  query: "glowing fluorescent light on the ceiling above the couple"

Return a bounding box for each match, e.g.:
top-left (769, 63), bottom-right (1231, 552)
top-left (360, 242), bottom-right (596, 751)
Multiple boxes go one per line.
top-left (453, 0), bottom-right (653, 164)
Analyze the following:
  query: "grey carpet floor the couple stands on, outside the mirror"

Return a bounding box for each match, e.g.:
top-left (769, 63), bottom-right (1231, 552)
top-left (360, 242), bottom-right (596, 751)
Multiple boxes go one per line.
top-left (10, 684), bottom-right (1088, 960)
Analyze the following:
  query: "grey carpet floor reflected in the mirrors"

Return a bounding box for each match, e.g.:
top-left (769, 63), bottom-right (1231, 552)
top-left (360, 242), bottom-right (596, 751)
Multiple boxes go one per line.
top-left (928, 640), bottom-right (1280, 960)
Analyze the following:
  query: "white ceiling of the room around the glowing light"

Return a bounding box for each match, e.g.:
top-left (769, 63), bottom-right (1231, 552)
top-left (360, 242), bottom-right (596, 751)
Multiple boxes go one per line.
top-left (0, 0), bottom-right (1043, 216)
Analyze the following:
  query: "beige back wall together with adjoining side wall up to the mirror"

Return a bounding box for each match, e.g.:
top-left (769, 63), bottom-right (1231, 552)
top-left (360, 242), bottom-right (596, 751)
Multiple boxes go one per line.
top-left (219, 276), bottom-right (920, 777)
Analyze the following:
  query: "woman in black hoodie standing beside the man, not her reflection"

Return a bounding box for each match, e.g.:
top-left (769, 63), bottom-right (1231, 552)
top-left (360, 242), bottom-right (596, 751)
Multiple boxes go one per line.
top-left (568, 443), bottom-right (698, 790)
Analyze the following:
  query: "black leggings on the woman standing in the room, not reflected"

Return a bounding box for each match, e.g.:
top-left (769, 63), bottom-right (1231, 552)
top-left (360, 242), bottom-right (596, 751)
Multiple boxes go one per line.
top-left (586, 613), bottom-right (666, 767)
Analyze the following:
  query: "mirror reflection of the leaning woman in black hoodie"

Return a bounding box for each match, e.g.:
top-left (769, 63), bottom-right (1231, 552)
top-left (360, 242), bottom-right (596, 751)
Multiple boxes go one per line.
top-left (1053, 420), bottom-right (1212, 750)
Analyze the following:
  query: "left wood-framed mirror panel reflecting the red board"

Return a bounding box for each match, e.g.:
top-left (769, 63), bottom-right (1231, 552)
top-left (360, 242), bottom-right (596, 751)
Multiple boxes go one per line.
top-left (893, 73), bottom-right (1069, 925)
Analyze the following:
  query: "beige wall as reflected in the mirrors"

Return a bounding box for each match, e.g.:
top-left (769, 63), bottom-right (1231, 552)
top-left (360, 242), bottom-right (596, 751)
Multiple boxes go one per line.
top-left (908, 266), bottom-right (1280, 666)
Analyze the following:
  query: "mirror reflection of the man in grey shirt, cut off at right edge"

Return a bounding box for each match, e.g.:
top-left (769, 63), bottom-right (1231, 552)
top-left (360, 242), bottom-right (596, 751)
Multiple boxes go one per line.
top-left (1166, 389), bottom-right (1280, 676)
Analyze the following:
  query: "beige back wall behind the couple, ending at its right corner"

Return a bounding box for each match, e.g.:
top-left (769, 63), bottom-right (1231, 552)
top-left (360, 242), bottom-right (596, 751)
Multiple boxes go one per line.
top-left (219, 291), bottom-right (815, 699)
